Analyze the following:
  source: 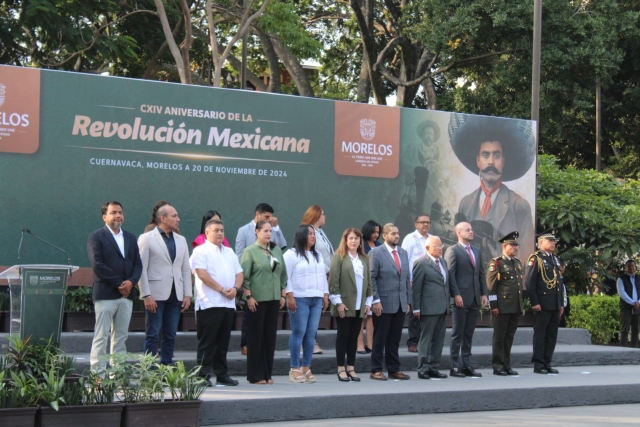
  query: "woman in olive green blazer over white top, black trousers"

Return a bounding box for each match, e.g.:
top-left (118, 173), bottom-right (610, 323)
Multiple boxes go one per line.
top-left (329, 228), bottom-right (373, 382)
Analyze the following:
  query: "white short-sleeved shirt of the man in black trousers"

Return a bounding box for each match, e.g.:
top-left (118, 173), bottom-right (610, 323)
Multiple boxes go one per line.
top-left (189, 240), bottom-right (242, 311)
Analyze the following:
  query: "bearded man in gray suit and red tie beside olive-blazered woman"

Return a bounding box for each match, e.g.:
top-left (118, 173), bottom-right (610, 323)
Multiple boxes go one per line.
top-left (369, 223), bottom-right (411, 380)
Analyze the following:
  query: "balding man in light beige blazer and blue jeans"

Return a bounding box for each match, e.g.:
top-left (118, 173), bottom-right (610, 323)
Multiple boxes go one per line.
top-left (138, 205), bottom-right (193, 365)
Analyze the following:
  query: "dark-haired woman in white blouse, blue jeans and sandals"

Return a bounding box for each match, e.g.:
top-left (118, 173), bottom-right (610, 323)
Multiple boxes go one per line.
top-left (284, 224), bottom-right (329, 383)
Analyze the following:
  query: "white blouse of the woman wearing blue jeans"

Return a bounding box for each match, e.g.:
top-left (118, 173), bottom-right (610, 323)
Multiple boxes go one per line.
top-left (283, 249), bottom-right (329, 298)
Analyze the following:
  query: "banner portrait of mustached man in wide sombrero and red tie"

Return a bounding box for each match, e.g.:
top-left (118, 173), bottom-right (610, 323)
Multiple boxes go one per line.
top-left (449, 114), bottom-right (536, 256)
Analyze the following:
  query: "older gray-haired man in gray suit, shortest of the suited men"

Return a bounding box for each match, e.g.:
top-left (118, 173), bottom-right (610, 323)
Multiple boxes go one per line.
top-left (412, 236), bottom-right (449, 380)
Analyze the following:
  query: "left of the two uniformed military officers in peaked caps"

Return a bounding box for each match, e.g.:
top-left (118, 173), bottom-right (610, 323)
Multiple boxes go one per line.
top-left (487, 231), bottom-right (522, 377)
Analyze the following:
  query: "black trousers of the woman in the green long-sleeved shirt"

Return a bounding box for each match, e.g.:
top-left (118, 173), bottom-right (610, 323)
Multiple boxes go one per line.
top-left (245, 300), bottom-right (280, 383)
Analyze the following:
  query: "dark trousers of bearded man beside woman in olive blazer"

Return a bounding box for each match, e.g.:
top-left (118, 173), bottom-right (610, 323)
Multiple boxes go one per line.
top-left (371, 307), bottom-right (405, 374)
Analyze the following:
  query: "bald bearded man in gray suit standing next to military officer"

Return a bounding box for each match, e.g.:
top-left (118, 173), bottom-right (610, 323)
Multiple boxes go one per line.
top-left (444, 222), bottom-right (489, 378)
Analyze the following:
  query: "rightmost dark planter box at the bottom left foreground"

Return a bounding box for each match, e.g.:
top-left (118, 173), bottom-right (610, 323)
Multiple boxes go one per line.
top-left (120, 400), bottom-right (202, 427)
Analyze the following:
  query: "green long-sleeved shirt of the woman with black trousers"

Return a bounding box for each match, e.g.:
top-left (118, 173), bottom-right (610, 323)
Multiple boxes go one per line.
top-left (240, 242), bottom-right (287, 302)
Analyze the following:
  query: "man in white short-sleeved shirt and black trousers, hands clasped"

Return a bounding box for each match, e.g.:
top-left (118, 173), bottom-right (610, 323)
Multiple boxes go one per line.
top-left (191, 219), bottom-right (244, 387)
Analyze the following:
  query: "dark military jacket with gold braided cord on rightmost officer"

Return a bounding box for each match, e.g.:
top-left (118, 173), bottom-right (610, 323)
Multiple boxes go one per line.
top-left (524, 251), bottom-right (564, 311)
